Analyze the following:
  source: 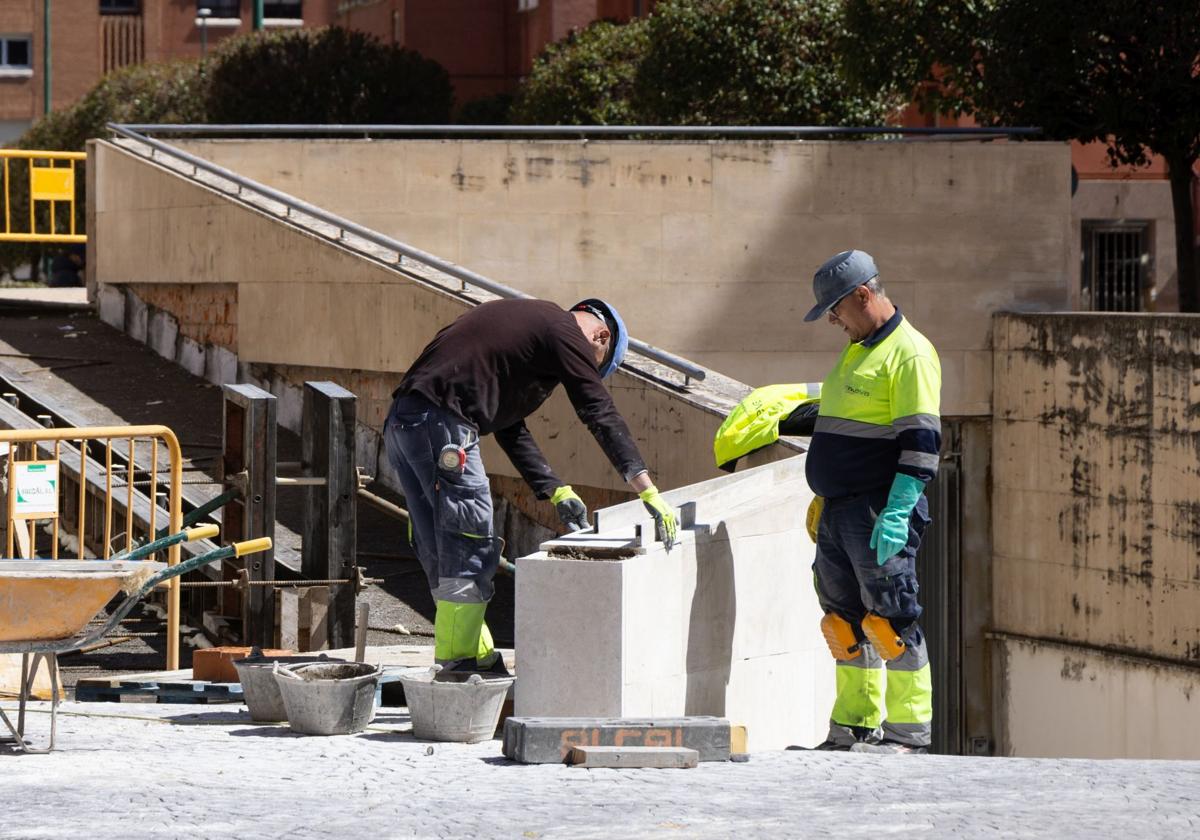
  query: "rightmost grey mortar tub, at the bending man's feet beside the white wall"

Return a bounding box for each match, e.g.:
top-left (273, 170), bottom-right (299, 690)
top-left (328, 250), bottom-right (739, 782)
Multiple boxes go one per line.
top-left (400, 667), bottom-right (514, 744)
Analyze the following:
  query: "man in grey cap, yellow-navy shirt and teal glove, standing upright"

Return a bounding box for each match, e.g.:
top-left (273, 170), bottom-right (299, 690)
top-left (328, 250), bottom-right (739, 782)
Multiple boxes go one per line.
top-left (804, 251), bottom-right (942, 752)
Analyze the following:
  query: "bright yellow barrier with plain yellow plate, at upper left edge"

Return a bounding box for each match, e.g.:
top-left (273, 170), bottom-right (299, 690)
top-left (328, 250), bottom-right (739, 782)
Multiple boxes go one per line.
top-left (0, 149), bottom-right (88, 242)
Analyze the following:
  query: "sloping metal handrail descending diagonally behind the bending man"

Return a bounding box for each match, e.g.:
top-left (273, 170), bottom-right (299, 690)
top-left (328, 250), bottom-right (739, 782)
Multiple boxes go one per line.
top-left (108, 122), bottom-right (706, 385)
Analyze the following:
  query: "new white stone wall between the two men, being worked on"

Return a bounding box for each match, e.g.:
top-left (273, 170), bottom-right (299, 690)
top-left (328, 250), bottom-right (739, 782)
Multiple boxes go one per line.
top-left (515, 456), bottom-right (834, 750)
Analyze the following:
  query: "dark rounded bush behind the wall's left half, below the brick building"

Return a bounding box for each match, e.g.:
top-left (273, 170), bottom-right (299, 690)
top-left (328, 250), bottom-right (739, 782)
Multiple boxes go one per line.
top-left (205, 26), bottom-right (454, 125)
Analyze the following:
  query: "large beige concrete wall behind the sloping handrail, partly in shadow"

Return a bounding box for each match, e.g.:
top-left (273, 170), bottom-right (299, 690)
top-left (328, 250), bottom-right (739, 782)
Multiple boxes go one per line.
top-left (164, 140), bottom-right (1078, 415)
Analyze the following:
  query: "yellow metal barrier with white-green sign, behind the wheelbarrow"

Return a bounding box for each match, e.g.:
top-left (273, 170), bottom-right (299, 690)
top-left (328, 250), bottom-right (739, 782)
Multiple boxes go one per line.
top-left (0, 426), bottom-right (184, 670)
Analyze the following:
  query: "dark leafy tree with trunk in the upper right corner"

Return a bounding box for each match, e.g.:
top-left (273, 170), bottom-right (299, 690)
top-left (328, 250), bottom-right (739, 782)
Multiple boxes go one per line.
top-left (844, 0), bottom-right (1200, 312)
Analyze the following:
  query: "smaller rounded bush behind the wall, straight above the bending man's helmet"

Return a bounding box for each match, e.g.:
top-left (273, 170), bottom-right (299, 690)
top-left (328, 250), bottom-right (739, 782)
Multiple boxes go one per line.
top-left (509, 19), bottom-right (647, 125)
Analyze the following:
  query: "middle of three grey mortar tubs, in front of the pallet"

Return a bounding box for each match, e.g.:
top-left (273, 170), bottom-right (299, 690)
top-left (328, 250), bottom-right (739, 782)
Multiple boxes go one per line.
top-left (274, 662), bottom-right (379, 734)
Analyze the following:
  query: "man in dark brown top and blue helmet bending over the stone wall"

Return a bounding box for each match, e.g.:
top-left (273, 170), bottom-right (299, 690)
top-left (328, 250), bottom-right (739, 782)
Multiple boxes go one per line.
top-left (384, 299), bottom-right (676, 680)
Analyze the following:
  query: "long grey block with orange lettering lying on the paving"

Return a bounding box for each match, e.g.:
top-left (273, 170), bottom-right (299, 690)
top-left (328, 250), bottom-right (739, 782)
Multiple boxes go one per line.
top-left (503, 710), bottom-right (731, 764)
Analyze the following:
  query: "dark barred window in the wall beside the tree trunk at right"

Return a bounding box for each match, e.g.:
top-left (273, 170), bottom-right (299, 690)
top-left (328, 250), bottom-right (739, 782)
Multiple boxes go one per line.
top-left (1080, 221), bottom-right (1153, 312)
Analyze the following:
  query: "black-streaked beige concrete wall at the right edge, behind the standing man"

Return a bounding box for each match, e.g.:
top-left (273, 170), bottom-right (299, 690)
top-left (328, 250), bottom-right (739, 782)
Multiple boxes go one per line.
top-left (992, 314), bottom-right (1200, 757)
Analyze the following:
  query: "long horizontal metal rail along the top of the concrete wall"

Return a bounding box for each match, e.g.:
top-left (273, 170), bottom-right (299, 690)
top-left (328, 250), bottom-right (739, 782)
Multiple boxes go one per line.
top-left (117, 124), bottom-right (1042, 137)
